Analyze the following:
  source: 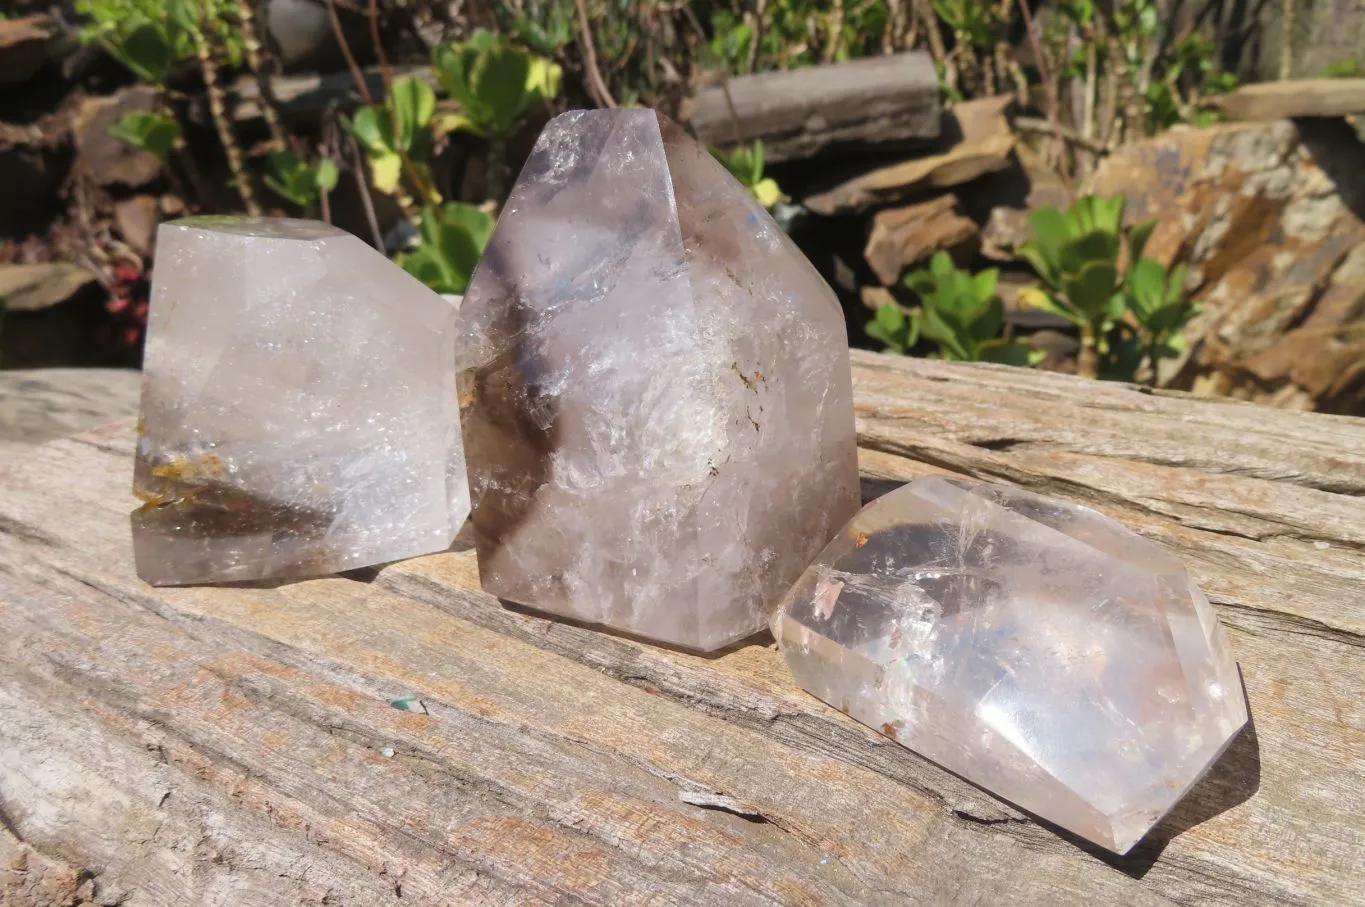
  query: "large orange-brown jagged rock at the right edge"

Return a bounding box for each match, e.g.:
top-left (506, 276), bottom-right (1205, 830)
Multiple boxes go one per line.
top-left (1088, 120), bottom-right (1365, 414)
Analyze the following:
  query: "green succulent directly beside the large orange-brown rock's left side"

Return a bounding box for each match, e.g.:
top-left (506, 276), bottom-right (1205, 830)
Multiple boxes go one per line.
top-left (1020, 195), bottom-right (1194, 380)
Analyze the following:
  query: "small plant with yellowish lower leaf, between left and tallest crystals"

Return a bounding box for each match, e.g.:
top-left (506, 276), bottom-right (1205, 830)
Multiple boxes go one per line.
top-left (351, 76), bottom-right (440, 204)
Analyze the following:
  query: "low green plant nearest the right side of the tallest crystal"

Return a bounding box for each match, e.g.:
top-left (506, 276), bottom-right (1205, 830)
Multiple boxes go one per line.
top-left (867, 251), bottom-right (1043, 365)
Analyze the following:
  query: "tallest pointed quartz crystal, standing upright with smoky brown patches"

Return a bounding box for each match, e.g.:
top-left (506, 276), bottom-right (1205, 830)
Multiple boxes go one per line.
top-left (459, 109), bottom-right (859, 650)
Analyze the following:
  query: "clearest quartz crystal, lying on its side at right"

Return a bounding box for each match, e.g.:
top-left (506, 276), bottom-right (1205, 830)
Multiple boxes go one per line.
top-left (773, 477), bottom-right (1246, 852)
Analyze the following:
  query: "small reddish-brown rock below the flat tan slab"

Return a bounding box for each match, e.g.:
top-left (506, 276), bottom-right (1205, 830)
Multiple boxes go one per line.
top-left (864, 195), bottom-right (981, 287)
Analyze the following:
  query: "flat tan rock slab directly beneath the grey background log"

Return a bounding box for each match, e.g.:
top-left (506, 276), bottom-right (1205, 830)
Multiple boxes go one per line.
top-left (804, 97), bottom-right (1014, 214)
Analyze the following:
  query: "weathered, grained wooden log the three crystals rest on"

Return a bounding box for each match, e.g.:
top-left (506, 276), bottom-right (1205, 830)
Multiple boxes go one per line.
top-left (0, 352), bottom-right (1365, 907)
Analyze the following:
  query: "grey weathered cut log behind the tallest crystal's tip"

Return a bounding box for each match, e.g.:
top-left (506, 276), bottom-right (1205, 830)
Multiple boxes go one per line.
top-left (691, 52), bottom-right (939, 161)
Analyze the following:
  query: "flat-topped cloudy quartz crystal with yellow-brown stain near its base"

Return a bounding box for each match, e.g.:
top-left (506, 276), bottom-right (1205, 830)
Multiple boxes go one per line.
top-left (132, 217), bottom-right (470, 583)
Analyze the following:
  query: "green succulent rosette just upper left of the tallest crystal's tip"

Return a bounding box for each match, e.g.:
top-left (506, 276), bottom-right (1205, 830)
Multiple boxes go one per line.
top-left (433, 29), bottom-right (564, 139)
